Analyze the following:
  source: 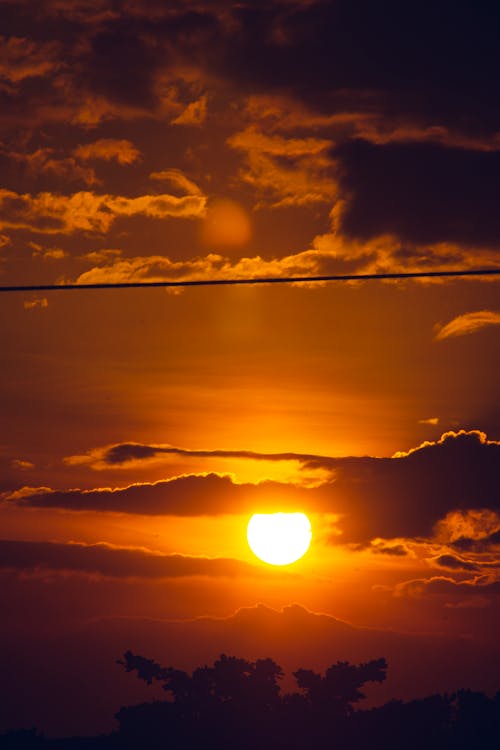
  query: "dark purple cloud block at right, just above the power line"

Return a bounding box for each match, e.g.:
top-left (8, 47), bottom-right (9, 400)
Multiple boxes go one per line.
top-left (336, 140), bottom-right (500, 248)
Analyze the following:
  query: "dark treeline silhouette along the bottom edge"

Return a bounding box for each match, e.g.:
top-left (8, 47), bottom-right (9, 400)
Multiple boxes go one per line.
top-left (0, 651), bottom-right (500, 750)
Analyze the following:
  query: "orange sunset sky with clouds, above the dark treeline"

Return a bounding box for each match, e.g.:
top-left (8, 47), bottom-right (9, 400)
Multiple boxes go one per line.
top-left (0, 0), bottom-right (500, 735)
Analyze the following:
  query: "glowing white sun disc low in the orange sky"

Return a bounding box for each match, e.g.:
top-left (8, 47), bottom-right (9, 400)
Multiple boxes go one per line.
top-left (247, 513), bottom-right (312, 565)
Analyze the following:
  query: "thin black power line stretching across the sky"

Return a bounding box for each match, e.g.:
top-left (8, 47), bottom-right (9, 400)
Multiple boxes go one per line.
top-left (0, 268), bottom-right (500, 292)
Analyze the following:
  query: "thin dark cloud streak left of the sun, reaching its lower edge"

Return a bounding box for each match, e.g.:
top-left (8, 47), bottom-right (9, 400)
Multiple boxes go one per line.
top-left (0, 540), bottom-right (266, 579)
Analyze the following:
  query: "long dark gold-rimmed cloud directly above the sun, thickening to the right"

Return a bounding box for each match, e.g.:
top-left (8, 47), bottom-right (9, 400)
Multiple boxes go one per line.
top-left (6, 430), bottom-right (500, 543)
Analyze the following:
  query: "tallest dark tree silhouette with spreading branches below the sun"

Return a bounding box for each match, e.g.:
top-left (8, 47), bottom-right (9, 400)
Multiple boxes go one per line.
top-left (118, 651), bottom-right (387, 750)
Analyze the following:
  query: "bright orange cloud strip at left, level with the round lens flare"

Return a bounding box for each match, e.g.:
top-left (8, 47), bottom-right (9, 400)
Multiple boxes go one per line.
top-left (0, 189), bottom-right (205, 234)
